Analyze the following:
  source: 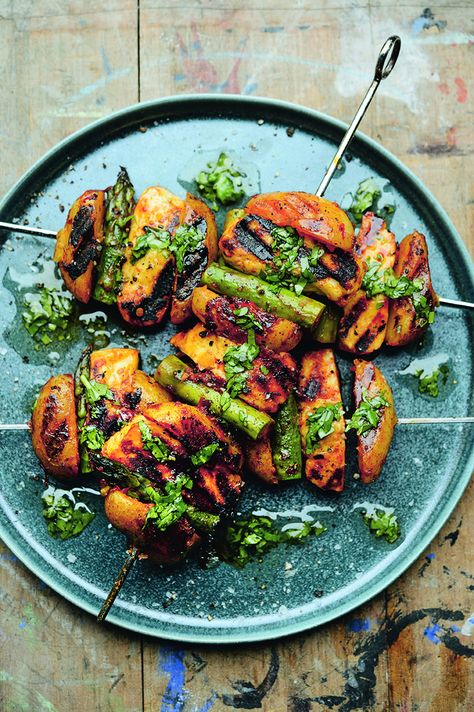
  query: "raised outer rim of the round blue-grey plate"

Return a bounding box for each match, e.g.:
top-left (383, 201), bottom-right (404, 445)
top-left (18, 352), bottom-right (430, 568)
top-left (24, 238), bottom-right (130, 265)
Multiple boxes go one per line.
top-left (0, 94), bottom-right (474, 645)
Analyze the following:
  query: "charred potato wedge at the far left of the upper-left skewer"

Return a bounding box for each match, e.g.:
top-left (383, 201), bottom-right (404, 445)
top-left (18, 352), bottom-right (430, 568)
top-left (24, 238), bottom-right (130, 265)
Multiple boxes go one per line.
top-left (53, 190), bottom-right (105, 304)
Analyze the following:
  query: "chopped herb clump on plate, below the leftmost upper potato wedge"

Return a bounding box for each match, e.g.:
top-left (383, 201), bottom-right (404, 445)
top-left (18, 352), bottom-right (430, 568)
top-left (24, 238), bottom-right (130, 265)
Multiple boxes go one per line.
top-left (21, 287), bottom-right (74, 346)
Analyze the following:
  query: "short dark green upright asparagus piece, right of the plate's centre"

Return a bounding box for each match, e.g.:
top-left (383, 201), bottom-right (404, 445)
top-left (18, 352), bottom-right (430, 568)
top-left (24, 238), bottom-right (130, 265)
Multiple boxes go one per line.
top-left (271, 393), bottom-right (303, 482)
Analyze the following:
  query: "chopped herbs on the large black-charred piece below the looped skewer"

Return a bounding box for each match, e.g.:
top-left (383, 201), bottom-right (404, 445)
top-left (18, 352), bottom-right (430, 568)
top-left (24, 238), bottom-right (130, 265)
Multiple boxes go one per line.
top-left (260, 227), bottom-right (324, 296)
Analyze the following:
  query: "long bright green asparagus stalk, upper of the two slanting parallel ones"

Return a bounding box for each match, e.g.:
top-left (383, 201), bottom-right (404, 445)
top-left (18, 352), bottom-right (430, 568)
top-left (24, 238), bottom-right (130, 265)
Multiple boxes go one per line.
top-left (202, 262), bottom-right (324, 329)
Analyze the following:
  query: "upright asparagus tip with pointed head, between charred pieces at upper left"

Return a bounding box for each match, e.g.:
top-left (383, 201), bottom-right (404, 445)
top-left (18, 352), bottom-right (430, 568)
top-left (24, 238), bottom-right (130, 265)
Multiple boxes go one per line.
top-left (93, 167), bottom-right (135, 304)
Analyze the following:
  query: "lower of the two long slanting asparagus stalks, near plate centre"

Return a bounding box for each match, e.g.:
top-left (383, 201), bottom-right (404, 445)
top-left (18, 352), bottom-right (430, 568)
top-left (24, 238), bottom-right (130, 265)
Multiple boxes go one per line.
top-left (155, 356), bottom-right (273, 440)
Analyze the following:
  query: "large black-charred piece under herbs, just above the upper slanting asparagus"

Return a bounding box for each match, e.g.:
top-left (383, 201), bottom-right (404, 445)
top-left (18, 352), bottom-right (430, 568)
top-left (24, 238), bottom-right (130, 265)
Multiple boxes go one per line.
top-left (219, 214), bottom-right (363, 302)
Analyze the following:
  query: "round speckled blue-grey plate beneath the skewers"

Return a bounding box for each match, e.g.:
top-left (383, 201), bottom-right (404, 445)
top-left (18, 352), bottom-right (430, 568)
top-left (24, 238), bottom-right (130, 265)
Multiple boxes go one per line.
top-left (0, 95), bottom-right (474, 643)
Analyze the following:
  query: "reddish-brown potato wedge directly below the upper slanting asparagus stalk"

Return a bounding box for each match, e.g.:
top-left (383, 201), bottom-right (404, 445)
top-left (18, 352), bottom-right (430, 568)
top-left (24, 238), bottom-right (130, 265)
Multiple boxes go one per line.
top-left (192, 287), bottom-right (303, 351)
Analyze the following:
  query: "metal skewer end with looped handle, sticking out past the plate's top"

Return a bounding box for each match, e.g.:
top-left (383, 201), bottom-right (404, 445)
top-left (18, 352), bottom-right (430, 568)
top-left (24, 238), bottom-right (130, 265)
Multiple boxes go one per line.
top-left (316, 35), bottom-right (402, 198)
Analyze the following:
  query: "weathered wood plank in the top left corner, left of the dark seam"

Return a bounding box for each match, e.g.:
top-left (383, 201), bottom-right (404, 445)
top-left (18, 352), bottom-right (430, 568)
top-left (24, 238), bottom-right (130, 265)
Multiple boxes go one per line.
top-left (0, 0), bottom-right (138, 193)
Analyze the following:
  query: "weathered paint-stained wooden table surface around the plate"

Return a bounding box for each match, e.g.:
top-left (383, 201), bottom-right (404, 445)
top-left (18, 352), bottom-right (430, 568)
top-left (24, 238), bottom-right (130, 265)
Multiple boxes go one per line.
top-left (0, 0), bottom-right (474, 712)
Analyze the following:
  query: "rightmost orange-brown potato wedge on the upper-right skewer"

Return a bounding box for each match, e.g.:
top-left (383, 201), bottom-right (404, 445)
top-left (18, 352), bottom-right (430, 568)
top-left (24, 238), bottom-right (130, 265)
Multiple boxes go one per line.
top-left (385, 231), bottom-right (438, 346)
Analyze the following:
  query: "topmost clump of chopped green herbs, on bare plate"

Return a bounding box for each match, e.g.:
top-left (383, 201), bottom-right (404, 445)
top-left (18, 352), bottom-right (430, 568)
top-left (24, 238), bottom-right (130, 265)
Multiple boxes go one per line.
top-left (195, 153), bottom-right (245, 211)
